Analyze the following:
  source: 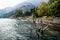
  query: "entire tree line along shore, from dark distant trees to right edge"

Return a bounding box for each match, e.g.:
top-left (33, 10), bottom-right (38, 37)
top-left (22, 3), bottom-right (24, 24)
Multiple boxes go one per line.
top-left (15, 0), bottom-right (60, 18)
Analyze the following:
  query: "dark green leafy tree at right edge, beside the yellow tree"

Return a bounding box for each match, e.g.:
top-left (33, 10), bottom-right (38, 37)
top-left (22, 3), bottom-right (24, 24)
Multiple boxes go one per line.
top-left (49, 0), bottom-right (60, 17)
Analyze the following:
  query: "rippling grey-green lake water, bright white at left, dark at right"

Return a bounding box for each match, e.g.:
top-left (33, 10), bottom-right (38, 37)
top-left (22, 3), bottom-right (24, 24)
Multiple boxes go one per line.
top-left (0, 18), bottom-right (60, 40)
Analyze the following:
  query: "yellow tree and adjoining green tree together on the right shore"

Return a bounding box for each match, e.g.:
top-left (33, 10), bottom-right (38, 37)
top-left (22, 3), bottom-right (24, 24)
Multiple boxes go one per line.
top-left (33, 0), bottom-right (60, 17)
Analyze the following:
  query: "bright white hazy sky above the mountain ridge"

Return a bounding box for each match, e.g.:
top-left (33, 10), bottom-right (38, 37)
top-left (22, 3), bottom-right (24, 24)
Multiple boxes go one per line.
top-left (0, 0), bottom-right (46, 9)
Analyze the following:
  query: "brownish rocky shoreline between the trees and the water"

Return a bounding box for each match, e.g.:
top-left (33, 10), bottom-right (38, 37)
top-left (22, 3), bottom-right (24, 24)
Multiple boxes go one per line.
top-left (17, 17), bottom-right (60, 31)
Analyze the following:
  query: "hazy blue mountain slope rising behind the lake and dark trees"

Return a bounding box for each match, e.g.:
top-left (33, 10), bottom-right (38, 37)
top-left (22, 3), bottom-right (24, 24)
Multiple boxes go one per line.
top-left (0, 2), bottom-right (35, 18)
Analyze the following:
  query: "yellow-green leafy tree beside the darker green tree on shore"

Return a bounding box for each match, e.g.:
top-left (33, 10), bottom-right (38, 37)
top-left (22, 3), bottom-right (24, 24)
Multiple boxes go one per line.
top-left (37, 2), bottom-right (48, 17)
